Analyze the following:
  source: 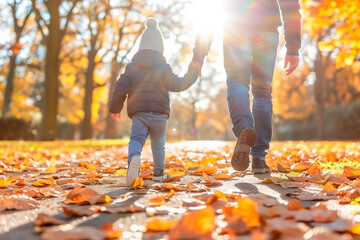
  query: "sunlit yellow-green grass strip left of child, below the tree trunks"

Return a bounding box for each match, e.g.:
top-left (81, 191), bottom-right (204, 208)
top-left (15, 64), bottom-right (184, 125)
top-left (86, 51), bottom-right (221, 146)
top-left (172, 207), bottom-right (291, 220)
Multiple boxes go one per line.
top-left (0, 138), bottom-right (129, 151)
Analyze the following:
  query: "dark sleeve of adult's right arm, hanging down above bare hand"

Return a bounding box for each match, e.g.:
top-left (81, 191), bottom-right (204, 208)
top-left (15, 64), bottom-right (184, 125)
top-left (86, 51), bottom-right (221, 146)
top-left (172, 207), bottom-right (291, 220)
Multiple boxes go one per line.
top-left (279, 0), bottom-right (301, 55)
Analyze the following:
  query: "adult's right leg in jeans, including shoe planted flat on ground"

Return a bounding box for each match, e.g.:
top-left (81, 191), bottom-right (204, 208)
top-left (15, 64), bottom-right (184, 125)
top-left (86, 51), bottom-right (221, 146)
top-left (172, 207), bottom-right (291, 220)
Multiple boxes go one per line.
top-left (251, 32), bottom-right (278, 172)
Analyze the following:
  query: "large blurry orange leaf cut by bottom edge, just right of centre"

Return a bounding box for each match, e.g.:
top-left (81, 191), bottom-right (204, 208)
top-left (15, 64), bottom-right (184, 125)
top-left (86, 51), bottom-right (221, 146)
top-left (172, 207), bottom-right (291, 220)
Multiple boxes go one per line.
top-left (169, 207), bottom-right (216, 239)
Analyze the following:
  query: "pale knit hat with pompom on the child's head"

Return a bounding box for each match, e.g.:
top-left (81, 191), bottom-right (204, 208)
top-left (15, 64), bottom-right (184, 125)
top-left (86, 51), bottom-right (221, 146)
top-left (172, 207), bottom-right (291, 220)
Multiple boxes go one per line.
top-left (139, 17), bottom-right (164, 52)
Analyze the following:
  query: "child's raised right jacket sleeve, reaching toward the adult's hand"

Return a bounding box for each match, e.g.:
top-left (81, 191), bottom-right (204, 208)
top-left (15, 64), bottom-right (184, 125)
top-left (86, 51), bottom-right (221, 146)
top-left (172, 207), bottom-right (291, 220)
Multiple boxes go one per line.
top-left (165, 62), bottom-right (200, 92)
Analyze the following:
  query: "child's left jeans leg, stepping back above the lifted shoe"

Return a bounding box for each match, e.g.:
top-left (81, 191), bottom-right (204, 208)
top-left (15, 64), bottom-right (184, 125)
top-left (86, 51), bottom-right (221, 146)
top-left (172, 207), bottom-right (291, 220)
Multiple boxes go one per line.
top-left (128, 113), bottom-right (150, 164)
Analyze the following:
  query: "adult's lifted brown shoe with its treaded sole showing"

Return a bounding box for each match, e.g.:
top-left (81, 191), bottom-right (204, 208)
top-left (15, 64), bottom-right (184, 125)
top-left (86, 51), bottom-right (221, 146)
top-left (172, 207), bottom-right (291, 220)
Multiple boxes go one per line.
top-left (231, 126), bottom-right (256, 171)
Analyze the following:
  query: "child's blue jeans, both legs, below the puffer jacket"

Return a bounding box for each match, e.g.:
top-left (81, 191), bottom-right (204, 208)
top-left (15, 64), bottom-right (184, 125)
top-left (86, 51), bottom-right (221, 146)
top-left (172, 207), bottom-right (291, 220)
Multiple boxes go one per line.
top-left (128, 112), bottom-right (168, 175)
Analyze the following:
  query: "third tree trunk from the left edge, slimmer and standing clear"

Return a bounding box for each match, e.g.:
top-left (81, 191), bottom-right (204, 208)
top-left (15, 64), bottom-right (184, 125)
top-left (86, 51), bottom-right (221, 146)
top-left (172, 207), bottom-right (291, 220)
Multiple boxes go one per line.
top-left (81, 48), bottom-right (96, 139)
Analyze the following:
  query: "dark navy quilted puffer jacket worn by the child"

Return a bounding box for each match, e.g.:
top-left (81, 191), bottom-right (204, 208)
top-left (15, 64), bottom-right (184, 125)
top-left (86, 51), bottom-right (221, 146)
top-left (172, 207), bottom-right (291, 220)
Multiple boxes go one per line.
top-left (109, 49), bottom-right (199, 118)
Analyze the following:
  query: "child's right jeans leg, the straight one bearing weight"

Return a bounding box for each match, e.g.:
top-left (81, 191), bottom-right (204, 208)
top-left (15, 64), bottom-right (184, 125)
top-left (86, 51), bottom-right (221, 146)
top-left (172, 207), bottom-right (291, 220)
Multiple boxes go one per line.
top-left (149, 113), bottom-right (168, 175)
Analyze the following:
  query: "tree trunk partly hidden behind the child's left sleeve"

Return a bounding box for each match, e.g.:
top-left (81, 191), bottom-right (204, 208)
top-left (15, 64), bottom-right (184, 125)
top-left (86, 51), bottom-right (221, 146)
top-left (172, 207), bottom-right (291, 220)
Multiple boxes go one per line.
top-left (105, 62), bottom-right (123, 139)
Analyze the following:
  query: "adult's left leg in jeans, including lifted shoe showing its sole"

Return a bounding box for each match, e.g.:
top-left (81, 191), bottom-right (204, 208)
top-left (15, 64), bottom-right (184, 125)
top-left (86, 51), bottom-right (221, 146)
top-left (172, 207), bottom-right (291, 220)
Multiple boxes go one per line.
top-left (224, 32), bottom-right (256, 171)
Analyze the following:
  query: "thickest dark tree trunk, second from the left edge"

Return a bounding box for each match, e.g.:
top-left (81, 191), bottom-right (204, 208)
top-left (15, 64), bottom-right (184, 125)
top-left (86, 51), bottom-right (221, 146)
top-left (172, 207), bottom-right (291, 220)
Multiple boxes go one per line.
top-left (40, 0), bottom-right (61, 140)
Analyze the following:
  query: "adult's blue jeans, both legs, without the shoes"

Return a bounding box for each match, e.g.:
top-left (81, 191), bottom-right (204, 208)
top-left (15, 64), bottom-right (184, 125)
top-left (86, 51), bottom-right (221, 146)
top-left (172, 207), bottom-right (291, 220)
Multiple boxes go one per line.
top-left (224, 30), bottom-right (279, 159)
